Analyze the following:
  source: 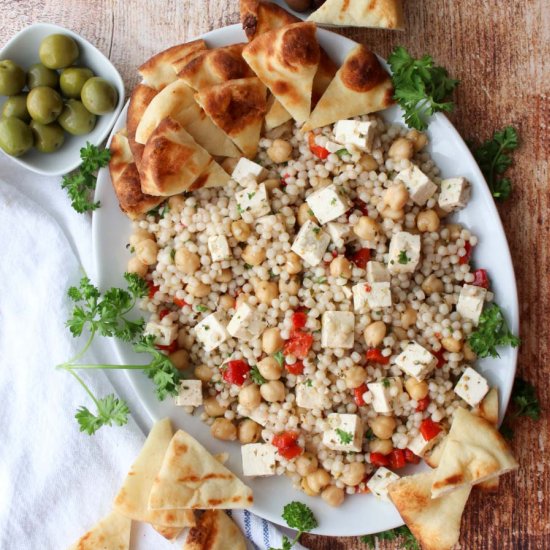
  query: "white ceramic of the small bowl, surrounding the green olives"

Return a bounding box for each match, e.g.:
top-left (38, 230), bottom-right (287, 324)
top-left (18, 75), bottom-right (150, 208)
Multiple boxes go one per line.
top-left (0, 23), bottom-right (124, 176)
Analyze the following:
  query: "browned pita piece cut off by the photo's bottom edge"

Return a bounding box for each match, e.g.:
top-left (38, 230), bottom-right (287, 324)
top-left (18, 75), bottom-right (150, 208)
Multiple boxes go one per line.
top-left (183, 510), bottom-right (246, 550)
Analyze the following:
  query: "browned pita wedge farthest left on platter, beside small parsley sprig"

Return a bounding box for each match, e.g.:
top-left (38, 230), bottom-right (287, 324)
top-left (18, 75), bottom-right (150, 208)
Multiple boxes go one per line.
top-left (109, 131), bottom-right (164, 220)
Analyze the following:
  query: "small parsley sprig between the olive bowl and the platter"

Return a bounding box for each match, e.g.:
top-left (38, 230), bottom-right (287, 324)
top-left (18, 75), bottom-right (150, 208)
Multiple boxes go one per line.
top-left (61, 142), bottom-right (111, 214)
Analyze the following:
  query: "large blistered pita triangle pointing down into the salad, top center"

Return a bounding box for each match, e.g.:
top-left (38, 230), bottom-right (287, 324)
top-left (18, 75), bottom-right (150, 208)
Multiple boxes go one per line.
top-left (243, 23), bottom-right (320, 123)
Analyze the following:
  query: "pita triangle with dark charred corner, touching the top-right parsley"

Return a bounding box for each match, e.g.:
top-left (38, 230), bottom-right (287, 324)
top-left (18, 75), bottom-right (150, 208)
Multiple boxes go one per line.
top-left (302, 44), bottom-right (393, 132)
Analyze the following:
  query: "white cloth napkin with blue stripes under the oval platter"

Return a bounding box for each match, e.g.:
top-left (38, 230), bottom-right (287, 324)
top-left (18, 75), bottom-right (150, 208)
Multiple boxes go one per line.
top-left (0, 169), bottom-right (302, 550)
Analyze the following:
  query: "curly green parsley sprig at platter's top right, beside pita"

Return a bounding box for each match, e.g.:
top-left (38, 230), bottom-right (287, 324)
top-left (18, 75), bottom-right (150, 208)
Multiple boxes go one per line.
top-left (388, 46), bottom-right (459, 130)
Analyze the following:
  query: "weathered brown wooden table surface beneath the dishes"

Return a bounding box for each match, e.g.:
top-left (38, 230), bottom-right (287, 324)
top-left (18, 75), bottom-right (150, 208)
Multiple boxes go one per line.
top-left (0, 0), bottom-right (550, 550)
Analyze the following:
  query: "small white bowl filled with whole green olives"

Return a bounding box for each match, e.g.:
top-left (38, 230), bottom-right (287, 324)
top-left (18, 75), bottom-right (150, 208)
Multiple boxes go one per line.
top-left (0, 23), bottom-right (124, 175)
